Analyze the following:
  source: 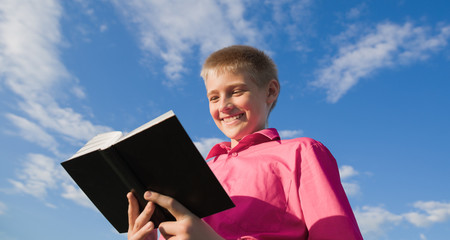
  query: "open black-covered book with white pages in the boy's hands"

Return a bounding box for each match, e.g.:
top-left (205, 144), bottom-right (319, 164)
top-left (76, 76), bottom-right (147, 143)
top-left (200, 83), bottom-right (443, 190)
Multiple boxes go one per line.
top-left (61, 111), bottom-right (234, 233)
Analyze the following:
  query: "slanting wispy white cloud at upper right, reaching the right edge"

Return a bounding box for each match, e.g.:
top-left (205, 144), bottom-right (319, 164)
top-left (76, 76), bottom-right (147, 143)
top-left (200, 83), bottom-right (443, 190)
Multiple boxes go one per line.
top-left (311, 22), bottom-right (450, 103)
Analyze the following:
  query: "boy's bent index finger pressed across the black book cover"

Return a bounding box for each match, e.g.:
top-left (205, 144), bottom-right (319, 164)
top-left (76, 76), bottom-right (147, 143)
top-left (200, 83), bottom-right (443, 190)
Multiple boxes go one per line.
top-left (144, 191), bottom-right (192, 220)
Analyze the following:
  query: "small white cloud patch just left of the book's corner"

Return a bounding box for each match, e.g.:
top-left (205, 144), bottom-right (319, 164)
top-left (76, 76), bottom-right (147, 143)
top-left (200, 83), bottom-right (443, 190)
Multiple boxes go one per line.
top-left (9, 154), bottom-right (61, 199)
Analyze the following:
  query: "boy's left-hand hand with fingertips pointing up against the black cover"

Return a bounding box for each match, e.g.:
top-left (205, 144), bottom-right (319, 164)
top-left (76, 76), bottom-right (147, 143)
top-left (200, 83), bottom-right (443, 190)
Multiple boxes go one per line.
top-left (127, 192), bottom-right (158, 240)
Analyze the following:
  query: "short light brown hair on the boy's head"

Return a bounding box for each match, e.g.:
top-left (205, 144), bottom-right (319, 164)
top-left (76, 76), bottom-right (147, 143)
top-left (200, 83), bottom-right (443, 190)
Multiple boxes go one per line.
top-left (200, 45), bottom-right (279, 110)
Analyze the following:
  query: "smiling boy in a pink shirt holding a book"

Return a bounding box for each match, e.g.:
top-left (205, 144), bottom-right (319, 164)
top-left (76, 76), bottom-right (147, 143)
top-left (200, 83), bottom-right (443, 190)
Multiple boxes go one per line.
top-left (128, 46), bottom-right (362, 240)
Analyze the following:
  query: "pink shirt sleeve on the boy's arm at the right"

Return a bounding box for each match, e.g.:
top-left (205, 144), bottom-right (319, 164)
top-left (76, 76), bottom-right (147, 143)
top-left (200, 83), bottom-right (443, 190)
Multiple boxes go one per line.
top-left (299, 142), bottom-right (363, 240)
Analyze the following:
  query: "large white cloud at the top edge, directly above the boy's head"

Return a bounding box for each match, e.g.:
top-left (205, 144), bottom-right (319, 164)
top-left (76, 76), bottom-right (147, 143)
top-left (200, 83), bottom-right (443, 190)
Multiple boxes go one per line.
top-left (113, 0), bottom-right (258, 86)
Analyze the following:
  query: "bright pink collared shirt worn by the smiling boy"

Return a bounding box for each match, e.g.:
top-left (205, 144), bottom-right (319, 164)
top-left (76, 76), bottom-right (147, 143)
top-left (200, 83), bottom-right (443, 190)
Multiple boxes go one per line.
top-left (204, 129), bottom-right (362, 240)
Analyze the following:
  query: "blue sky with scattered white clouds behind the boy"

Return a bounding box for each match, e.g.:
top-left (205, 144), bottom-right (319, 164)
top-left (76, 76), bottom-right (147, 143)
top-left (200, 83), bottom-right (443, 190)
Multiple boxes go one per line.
top-left (0, 0), bottom-right (450, 240)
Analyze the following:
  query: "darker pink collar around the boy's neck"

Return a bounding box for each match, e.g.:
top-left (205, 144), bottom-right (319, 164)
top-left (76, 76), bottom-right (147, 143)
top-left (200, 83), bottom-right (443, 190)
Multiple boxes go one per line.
top-left (206, 128), bottom-right (280, 159)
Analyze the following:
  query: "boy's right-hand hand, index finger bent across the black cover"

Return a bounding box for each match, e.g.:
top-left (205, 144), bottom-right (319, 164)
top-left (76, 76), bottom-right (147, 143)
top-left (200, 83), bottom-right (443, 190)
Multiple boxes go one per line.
top-left (145, 192), bottom-right (223, 240)
